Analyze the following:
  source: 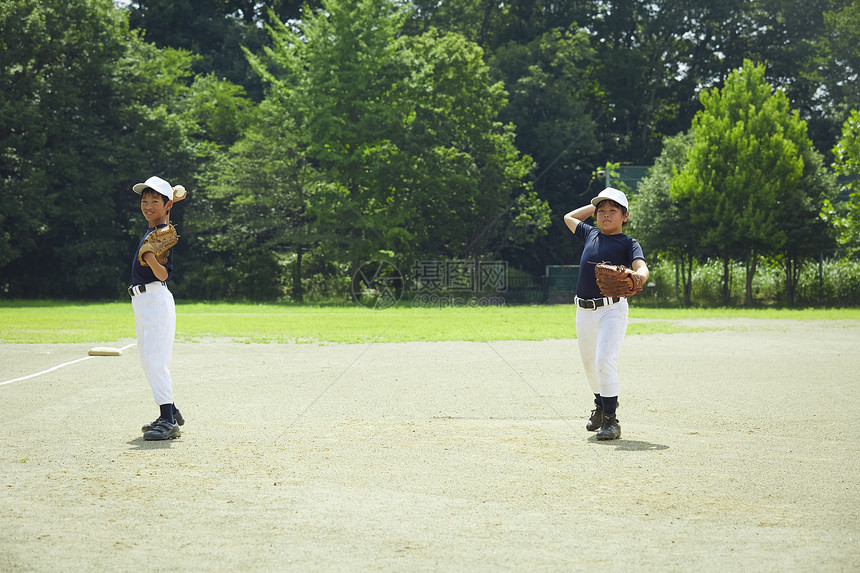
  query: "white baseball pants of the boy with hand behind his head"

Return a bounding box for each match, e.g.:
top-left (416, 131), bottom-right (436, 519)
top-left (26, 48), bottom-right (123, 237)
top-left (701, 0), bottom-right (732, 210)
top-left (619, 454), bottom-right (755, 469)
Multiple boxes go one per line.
top-left (576, 298), bottom-right (630, 398)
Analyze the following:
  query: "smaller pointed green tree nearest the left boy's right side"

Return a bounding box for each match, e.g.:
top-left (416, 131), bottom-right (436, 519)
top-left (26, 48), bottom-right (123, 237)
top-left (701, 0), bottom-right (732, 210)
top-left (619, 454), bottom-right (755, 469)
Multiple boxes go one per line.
top-left (194, 100), bottom-right (336, 302)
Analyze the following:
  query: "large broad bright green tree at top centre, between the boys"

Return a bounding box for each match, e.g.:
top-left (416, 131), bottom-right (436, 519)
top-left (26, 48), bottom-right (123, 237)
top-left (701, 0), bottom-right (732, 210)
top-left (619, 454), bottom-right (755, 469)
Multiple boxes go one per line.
top-left (245, 0), bottom-right (546, 272)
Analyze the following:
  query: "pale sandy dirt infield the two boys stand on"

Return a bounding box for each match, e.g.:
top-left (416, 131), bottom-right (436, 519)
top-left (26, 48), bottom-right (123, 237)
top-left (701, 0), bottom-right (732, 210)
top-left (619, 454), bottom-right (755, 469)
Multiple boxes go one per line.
top-left (0, 320), bottom-right (860, 572)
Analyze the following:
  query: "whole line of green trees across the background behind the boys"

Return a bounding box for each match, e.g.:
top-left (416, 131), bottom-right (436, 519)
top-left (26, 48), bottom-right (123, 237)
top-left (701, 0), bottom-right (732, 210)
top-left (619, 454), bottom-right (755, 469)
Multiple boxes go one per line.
top-left (0, 0), bottom-right (860, 303)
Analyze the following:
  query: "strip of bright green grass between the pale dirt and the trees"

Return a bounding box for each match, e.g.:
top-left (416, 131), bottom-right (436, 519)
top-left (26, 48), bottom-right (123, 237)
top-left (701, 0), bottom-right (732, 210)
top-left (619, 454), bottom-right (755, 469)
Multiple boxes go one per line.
top-left (0, 301), bottom-right (860, 344)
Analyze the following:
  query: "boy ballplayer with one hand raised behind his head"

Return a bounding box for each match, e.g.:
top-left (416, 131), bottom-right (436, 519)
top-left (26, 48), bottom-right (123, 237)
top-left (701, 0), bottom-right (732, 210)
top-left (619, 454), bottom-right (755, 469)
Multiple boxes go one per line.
top-left (564, 187), bottom-right (649, 440)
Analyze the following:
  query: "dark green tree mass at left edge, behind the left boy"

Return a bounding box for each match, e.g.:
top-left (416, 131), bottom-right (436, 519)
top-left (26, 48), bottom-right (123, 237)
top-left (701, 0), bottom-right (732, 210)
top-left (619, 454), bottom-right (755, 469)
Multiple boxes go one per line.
top-left (0, 0), bottom-right (190, 297)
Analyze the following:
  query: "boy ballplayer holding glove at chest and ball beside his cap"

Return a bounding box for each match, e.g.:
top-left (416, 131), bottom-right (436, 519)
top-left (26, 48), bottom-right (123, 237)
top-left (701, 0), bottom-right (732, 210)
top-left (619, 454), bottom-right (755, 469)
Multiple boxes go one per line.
top-left (128, 177), bottom-right (185, 440)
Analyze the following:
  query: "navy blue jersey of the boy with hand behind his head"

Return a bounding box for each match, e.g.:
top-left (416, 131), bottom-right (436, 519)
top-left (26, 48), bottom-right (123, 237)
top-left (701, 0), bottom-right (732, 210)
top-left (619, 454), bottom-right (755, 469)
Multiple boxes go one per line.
top-left (573, 222), bottom-right (645, 298)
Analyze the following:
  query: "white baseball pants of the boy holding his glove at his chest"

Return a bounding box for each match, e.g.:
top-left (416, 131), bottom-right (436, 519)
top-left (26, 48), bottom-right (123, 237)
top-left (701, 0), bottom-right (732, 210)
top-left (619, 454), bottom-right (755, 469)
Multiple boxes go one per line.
top-left (131, 282), bottom-right (176, 406)
